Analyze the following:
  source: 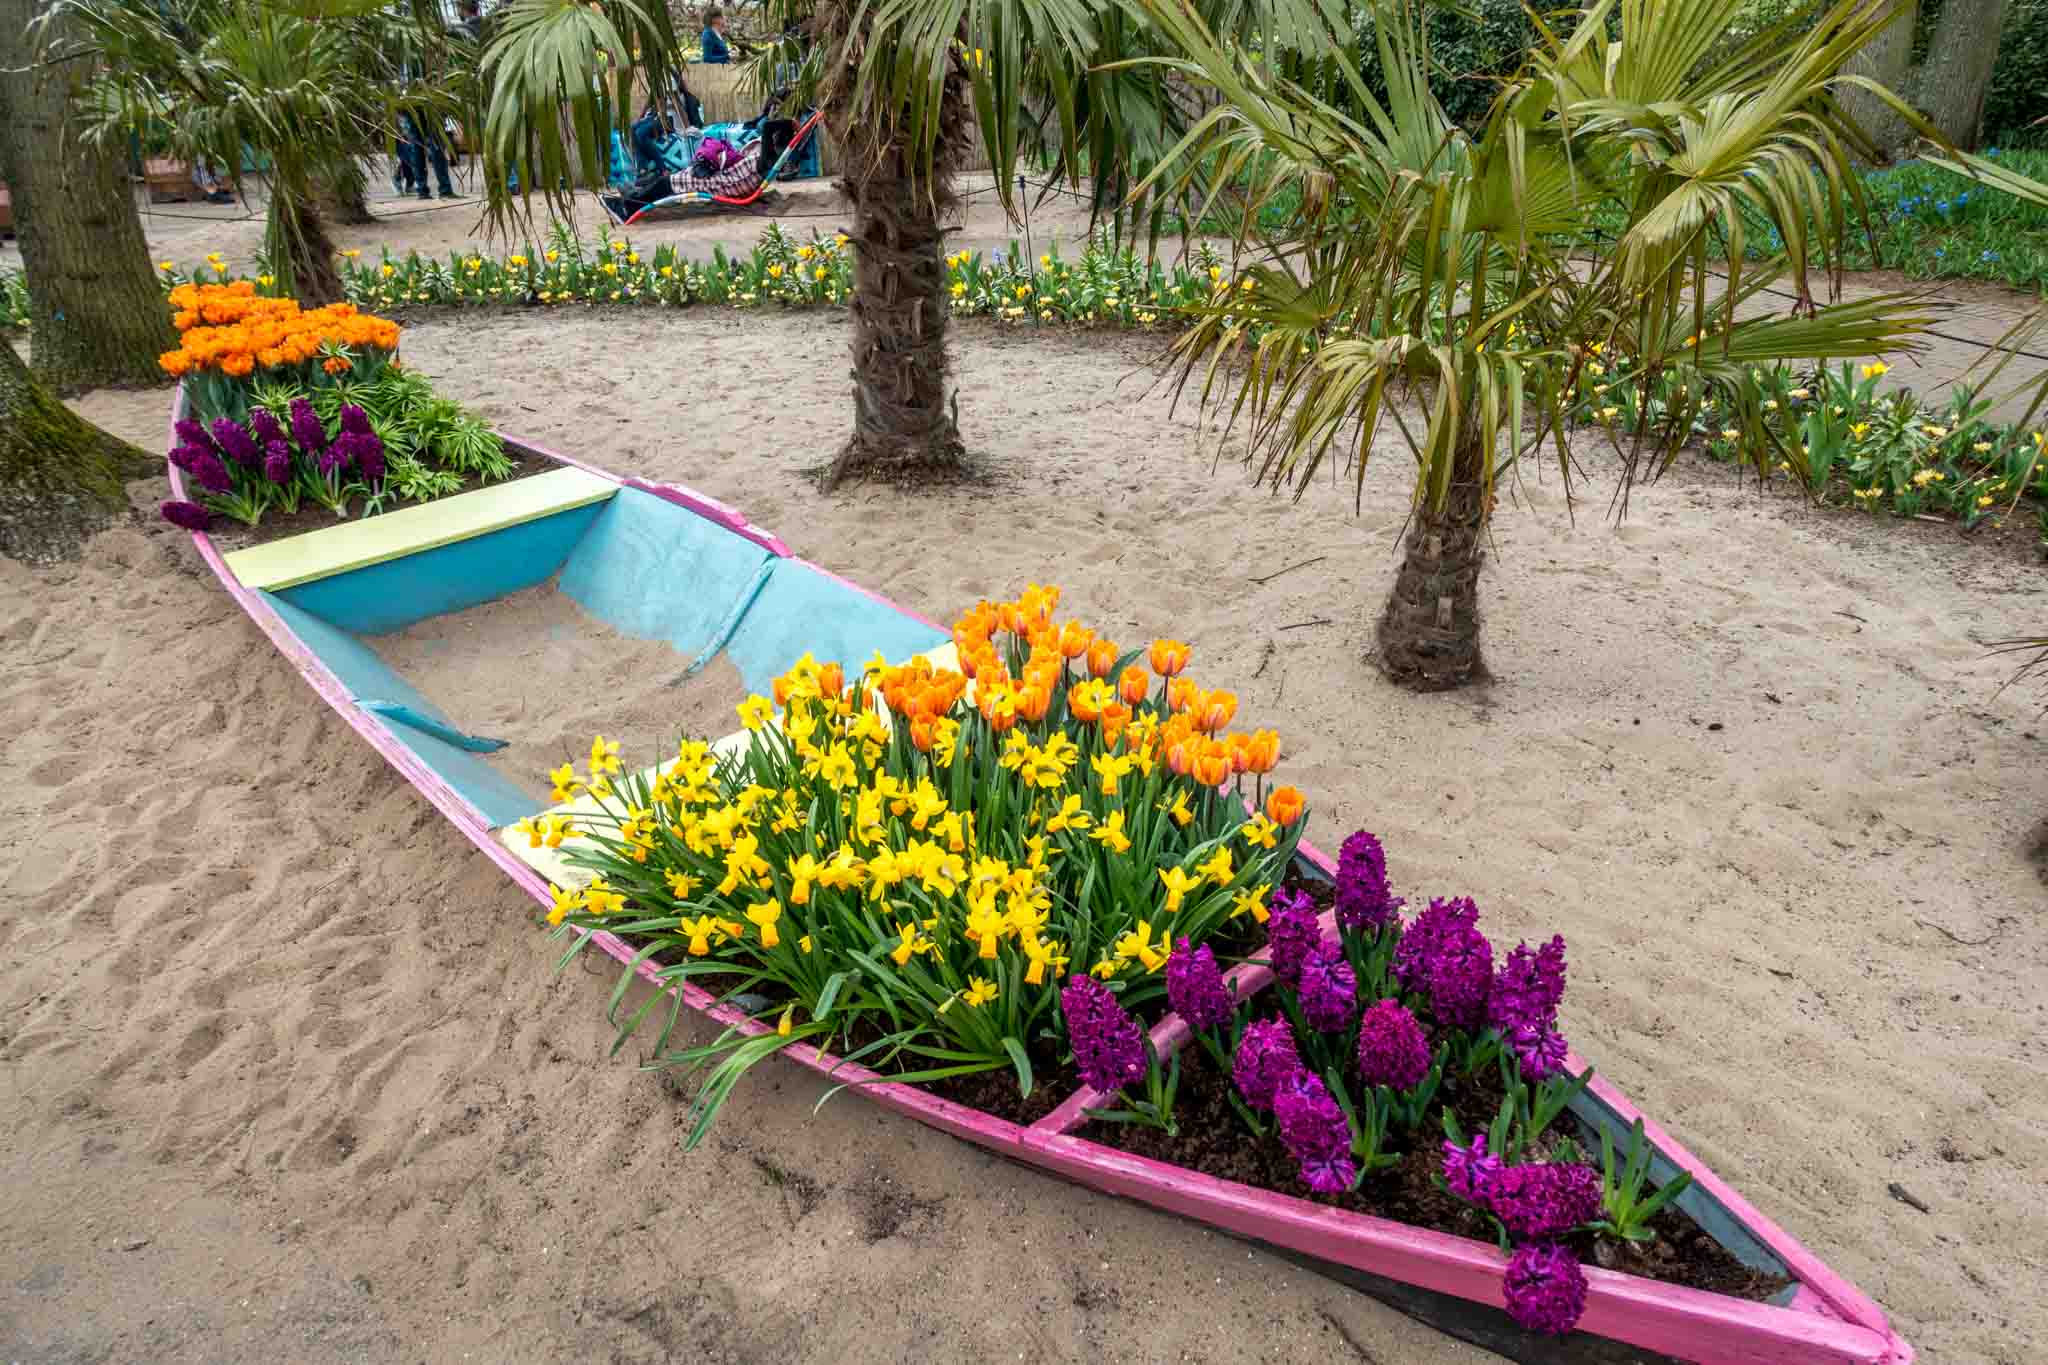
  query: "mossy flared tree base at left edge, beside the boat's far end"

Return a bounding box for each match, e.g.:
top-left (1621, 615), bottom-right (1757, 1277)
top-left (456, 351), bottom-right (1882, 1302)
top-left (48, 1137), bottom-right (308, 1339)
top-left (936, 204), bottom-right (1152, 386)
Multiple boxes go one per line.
top-left (0, 342), bottom-right (154, 563)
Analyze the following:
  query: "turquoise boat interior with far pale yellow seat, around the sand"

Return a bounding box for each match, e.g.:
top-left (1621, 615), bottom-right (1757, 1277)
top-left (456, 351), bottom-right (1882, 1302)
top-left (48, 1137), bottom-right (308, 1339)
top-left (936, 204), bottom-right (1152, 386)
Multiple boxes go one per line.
top-left (225, 469), bottom-right (948, 827)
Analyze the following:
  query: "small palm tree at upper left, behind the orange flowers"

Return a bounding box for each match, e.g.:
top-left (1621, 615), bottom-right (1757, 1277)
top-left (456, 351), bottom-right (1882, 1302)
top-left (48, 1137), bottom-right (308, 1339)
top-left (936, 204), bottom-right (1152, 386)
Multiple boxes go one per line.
top-left (53, 0), bottom-right (475, 305)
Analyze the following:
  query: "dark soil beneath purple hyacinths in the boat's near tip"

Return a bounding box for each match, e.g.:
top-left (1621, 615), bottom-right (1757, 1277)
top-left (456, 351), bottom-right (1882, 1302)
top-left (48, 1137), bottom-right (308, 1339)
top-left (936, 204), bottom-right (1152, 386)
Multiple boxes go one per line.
top-left (1081, 1048), bottom-right (1788, 1300)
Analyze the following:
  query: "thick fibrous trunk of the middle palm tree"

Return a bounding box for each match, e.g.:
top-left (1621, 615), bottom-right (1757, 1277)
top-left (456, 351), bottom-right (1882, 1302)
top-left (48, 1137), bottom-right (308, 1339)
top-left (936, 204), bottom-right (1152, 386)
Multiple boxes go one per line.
top-left (819, 4), bottom-right (971, 489)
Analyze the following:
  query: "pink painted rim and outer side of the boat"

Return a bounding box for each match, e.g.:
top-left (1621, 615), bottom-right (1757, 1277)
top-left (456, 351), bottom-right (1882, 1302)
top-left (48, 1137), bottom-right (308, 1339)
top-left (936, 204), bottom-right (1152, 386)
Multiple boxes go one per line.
top-left (170, 401), bottom-right (1913, 1365)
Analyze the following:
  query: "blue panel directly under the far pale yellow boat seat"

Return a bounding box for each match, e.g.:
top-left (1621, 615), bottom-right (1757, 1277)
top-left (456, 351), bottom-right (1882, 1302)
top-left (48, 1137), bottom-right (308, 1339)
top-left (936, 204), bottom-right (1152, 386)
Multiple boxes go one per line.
top-left (276, 501), bottom-right (598, 634)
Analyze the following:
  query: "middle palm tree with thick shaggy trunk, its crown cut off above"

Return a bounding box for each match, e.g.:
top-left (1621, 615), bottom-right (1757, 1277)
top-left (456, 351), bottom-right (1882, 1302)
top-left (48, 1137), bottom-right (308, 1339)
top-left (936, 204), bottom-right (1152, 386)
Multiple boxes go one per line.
top-left (483, 0), bottom-right (1286, 487)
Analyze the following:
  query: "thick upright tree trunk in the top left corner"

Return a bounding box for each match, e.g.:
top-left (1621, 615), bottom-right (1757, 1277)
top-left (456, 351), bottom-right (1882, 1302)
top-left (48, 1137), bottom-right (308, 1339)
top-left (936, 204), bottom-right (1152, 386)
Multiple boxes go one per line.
top-left (0, 0), bottom-right (172, 393)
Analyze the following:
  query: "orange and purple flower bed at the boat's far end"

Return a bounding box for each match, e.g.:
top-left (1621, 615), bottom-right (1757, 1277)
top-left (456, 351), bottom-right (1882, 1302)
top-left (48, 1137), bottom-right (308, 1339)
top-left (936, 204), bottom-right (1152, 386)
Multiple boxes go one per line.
top-left (162, 280), bottom-right (516, 534)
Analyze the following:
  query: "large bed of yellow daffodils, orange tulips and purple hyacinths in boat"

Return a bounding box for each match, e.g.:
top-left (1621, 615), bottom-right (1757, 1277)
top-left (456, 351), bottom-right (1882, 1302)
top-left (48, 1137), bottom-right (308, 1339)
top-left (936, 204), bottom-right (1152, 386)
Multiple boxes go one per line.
top-left (520, 587), bottom-right (1761, 1332)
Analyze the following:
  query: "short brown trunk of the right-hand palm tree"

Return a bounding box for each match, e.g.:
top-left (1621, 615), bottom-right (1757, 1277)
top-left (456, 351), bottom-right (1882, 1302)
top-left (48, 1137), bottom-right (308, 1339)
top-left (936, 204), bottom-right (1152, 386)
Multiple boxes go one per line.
top-left (1380, 464), bottom-right (1487, 692)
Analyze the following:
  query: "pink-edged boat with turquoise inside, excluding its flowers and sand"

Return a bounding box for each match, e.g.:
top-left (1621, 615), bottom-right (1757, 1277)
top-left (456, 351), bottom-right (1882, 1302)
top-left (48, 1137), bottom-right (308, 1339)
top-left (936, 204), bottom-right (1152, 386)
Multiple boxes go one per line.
top-left (170, 399), bottom-right (1913, 1365)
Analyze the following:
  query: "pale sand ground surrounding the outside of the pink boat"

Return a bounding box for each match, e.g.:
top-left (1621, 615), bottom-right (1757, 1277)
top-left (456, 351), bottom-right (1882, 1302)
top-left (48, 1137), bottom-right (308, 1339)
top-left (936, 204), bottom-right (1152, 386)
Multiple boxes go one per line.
top-left (0, 311), bottom-right (2048, 1363)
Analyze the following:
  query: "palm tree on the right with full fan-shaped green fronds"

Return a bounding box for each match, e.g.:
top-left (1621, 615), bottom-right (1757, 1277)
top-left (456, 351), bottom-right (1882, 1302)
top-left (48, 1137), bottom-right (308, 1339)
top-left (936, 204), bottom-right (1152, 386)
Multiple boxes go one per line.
top-left (1143, 0), bottom-right (1929, 690)
